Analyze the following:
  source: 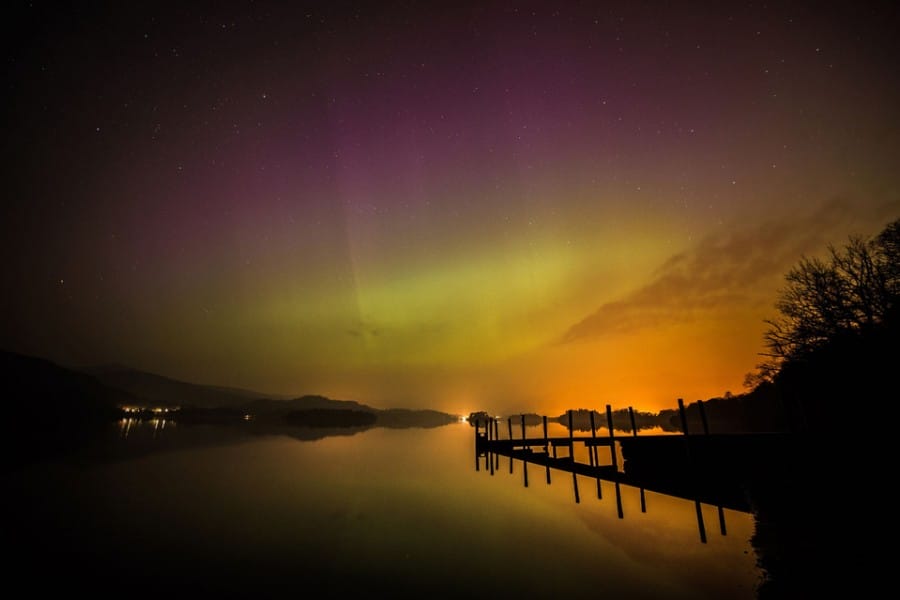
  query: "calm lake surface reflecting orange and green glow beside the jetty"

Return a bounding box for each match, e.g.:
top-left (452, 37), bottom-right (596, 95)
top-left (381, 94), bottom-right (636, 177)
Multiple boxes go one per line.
top-left (10, 423), bottom-right (761, 599)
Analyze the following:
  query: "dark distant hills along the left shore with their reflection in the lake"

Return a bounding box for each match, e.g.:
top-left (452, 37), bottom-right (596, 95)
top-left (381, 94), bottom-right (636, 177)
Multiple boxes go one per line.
top-left (0, 350), bottom-right (458, 466)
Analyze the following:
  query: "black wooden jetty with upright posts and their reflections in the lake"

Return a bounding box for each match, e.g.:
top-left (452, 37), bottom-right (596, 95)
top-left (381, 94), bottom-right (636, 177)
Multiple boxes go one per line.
top-left (474, 400), bottom-right (793, 542)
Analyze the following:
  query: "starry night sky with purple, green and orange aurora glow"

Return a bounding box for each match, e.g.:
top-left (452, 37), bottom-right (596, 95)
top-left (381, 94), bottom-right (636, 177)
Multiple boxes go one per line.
top-left (0, 2), bottom-right (900, 414)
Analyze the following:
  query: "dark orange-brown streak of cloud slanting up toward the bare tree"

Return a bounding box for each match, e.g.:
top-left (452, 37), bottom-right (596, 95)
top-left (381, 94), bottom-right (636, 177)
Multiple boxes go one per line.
top-left (559, 200), bottom-right (900, 343)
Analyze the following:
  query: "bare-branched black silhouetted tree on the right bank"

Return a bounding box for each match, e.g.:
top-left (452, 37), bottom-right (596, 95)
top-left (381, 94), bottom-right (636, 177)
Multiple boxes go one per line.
top-left (745, 219), bottom-right (900, 432)
